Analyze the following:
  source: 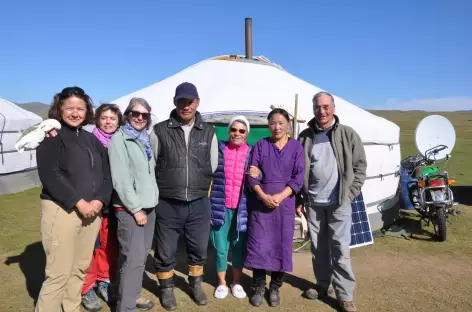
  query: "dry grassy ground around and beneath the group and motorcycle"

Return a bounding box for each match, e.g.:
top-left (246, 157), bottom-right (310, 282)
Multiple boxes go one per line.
top-left (0, 112), bottom-right (472, 311)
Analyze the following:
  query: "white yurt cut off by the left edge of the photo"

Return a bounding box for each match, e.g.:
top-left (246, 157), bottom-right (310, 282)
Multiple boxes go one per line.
top-left (0, 99), bottom-right (42, 194)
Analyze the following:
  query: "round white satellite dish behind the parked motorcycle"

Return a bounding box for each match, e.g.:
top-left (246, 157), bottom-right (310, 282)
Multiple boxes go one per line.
top-left (415, 115), bottom-right (456, 160)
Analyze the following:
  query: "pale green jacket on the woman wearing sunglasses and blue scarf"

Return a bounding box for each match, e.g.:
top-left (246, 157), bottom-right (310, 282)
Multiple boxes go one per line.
top-left (108, 129), bottom-right (159, 213)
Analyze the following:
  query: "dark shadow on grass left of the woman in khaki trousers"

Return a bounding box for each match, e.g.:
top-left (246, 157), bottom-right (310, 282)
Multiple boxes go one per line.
top-left (5, 242), bottom-right (46, 306)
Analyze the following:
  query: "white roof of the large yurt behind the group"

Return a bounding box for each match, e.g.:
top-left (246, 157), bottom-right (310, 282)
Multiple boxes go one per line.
top-left (113, 55), bottom-right (400, 144)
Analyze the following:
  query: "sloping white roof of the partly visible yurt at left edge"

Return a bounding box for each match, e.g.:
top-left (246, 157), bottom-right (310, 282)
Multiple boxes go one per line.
top-left (0, 98), bottom-right (43, 132)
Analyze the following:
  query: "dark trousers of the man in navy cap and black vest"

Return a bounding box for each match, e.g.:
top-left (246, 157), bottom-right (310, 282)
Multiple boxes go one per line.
top-left (154, 197), bottom-right (211, 273)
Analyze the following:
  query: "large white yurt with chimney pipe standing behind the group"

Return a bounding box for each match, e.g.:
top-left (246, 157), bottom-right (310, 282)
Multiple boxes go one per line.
top-left (113, 56), bottom-right (400, 230)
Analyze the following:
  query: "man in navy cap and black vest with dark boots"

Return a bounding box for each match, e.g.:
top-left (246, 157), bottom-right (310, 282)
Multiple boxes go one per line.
top-left (151, 82), bottom-right (218, 310)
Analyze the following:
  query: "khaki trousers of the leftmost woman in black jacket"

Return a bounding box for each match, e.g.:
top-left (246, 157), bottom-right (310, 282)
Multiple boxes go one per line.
top-left (35, 200), bottom-right (100, 312)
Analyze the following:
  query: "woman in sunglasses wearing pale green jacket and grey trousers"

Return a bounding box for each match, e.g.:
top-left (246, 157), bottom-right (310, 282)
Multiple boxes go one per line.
top-left (108, 98), bottom-right (159, 312)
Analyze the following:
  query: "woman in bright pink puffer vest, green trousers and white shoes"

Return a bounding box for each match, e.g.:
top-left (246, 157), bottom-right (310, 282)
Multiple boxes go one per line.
top-left (210, 116), bottom-right (259, 299)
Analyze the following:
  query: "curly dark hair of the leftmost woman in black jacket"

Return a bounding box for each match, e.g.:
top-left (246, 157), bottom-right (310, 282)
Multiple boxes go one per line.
top-left (48, 86), bottom-right (94, 126)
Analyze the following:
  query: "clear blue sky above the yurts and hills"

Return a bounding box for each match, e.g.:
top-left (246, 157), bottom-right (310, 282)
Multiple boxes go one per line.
top-left (0, 0), bottom-right (472, 109)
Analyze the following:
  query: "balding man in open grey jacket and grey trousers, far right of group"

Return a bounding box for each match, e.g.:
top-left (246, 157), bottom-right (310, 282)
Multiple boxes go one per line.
top-left (297, 92), bottom-right (367, 312)
